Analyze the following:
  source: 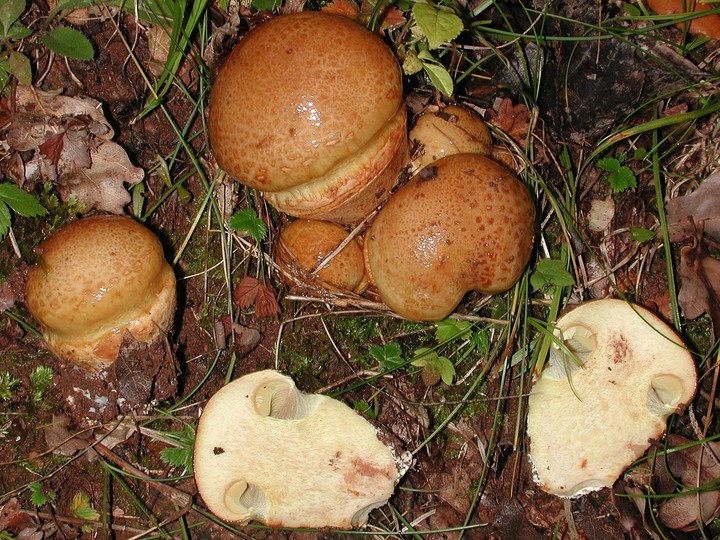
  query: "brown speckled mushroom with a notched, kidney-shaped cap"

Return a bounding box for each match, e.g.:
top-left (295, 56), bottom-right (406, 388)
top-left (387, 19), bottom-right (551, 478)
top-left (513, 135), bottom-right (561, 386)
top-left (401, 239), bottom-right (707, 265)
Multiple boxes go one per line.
top-left (364, 154), bottom-right (535, 320)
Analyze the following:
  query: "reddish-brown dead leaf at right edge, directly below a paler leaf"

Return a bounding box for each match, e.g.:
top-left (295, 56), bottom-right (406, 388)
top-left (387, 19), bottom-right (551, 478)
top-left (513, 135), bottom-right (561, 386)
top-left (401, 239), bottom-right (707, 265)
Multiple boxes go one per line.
top-left (678, 222), bottom-right (720, 336)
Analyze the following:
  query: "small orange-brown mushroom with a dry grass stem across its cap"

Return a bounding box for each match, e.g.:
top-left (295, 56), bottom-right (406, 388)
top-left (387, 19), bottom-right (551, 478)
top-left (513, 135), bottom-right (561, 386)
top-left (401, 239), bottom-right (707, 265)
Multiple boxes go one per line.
top-left (275, 219), bottom-right (367, 294)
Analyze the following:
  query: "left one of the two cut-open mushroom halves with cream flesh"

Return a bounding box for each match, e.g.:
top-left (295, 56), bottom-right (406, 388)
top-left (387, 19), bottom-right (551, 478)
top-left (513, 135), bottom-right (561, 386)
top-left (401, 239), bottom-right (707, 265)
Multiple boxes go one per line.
top-left (194, 370), bottom-right (402, 529)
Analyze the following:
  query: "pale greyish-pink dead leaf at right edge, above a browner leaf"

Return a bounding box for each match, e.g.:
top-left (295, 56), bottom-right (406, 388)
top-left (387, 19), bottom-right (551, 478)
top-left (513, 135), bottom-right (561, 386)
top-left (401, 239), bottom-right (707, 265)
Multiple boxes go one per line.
top-left (667, 171), bottom-right (720, 242)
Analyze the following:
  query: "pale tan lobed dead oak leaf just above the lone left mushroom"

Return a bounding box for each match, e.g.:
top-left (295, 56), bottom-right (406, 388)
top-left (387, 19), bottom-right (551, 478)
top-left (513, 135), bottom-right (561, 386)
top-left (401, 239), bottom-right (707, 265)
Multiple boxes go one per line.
top-left (57, 142), bottom-right (145, 214)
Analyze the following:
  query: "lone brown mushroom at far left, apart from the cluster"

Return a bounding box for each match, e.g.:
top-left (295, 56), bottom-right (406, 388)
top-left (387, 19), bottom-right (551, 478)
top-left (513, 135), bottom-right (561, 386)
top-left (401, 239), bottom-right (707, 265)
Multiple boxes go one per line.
top-left (25, 215), bottom-right (175, 371)
